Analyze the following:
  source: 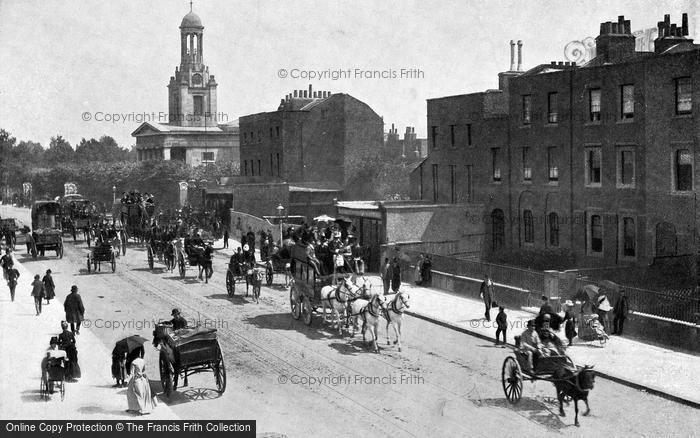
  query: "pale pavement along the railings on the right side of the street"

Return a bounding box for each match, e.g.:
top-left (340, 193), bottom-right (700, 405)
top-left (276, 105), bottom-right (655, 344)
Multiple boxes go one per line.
top-left (215, 239), bottom-right (700, 408)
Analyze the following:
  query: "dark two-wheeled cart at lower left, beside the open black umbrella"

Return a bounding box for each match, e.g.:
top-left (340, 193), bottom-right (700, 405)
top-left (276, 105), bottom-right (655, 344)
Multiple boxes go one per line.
top-left (153, 324), bottom-right (226, 397)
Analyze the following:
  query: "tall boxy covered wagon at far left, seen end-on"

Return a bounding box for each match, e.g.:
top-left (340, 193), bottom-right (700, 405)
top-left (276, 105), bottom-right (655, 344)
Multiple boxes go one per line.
top-left (28, 201), bottom-right (63, 258)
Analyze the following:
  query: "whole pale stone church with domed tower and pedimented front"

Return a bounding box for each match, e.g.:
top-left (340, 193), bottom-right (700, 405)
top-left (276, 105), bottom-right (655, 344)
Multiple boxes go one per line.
top-left (131, 11), bottom-right (239, 166)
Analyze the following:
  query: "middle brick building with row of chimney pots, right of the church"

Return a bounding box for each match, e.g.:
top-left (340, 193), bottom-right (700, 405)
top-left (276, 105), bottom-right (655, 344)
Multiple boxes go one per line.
top-left (240, 86), bottom-right (384, 199)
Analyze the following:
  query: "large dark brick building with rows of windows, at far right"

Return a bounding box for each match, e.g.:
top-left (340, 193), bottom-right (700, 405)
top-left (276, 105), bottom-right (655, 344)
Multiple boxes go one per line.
top-left (414, 14), bottom-right (700, 266)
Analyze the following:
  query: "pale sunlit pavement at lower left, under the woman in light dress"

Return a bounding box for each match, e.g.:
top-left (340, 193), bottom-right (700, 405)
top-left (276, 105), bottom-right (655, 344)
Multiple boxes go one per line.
top-left (0, 250), bottom-right (178, 420)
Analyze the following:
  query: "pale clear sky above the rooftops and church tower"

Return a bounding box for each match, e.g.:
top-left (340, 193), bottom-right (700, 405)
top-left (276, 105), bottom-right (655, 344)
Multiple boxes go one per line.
top-left (0, 0), bottom-right (700, 147)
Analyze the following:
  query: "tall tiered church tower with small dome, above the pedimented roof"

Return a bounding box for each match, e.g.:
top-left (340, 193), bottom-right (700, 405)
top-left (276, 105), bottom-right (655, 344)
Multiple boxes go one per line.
top-left (168, 2), bottom-right (219, 127)
